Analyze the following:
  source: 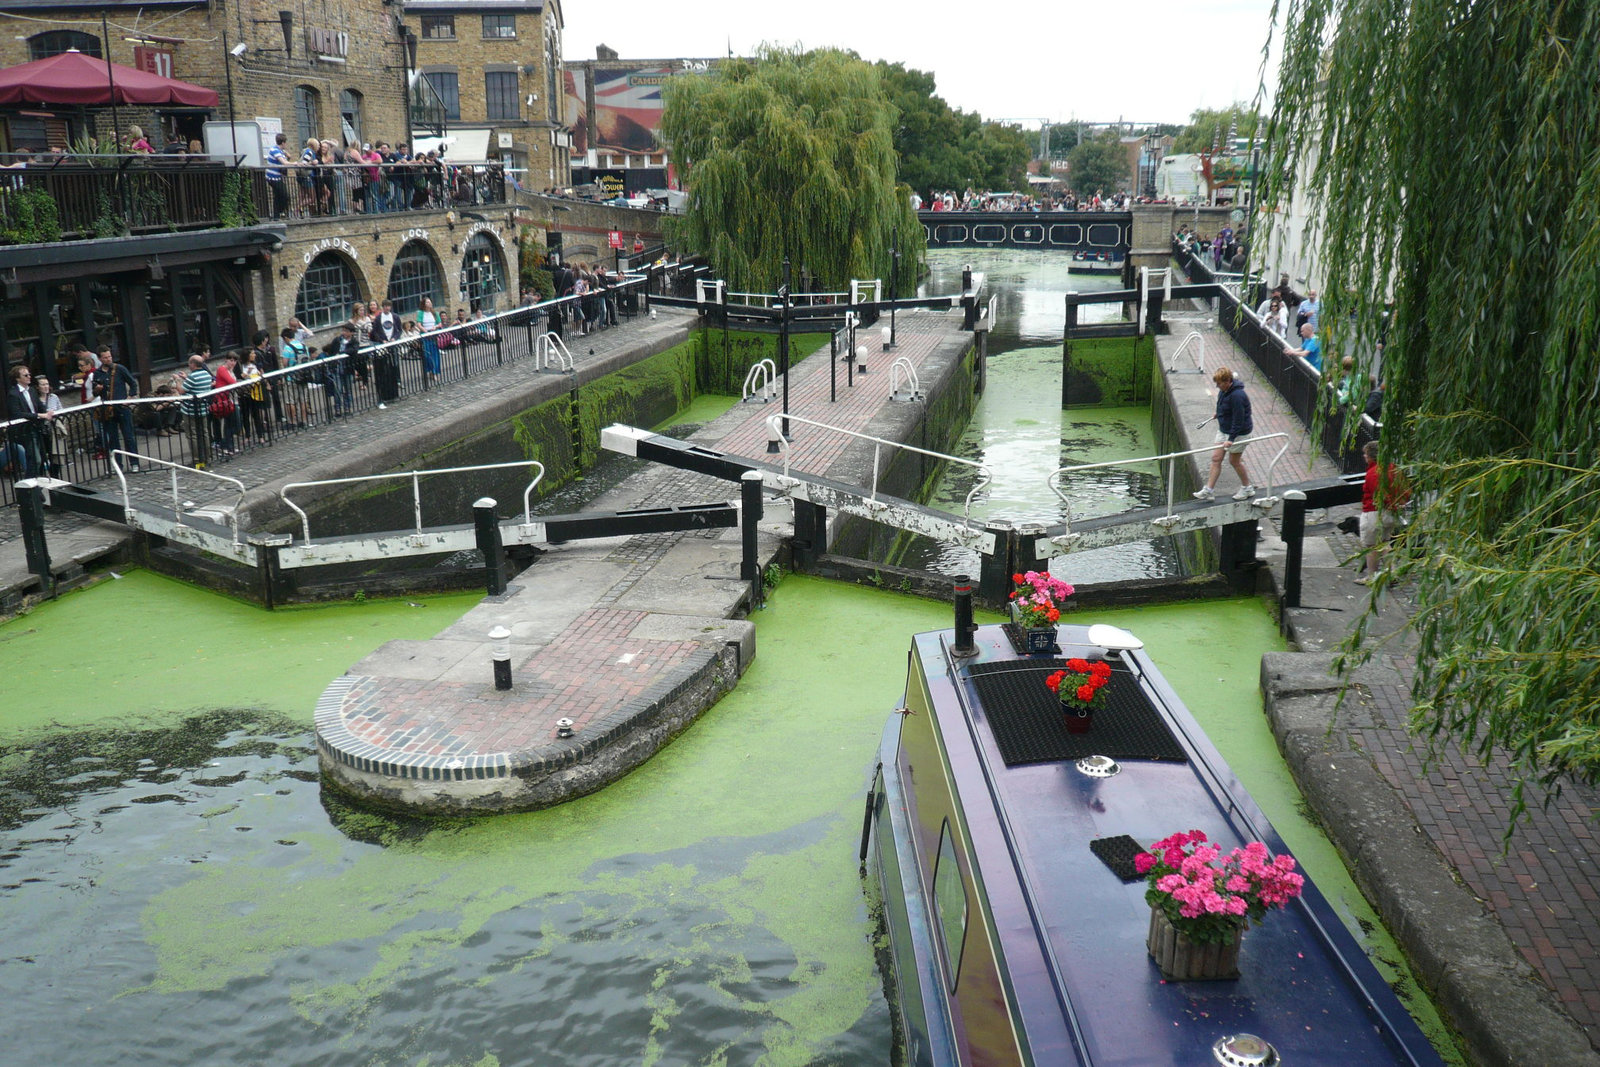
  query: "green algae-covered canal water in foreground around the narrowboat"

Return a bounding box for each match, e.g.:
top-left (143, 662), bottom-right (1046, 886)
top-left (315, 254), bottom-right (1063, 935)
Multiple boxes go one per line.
top-left (0, 254), bottom-right (1459, 1067)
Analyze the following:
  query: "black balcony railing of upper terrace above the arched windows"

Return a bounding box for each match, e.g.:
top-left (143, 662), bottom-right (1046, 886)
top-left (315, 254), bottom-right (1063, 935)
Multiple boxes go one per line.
top-left (0, 155), bottom-right (506, 245)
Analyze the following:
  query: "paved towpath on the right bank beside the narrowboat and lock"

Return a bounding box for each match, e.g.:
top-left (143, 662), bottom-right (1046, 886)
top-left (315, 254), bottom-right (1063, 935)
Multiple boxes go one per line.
top-left (1160, 307), bottom-right (1600, 1064)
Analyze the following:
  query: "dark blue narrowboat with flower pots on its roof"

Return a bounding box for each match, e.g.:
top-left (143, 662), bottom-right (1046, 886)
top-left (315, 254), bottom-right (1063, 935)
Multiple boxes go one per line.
top-left (861, 607), bottom-right (1442, 1067)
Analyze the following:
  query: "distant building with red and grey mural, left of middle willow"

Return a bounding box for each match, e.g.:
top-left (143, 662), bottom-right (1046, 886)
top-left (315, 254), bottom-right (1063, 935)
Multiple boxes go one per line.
top-left (565, 45), bottom-right (718, 197)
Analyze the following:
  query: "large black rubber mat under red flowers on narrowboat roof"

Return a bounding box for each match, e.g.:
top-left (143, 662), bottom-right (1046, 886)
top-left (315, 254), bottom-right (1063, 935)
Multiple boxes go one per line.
top-left (970, 659), bottom-right (1189, 766)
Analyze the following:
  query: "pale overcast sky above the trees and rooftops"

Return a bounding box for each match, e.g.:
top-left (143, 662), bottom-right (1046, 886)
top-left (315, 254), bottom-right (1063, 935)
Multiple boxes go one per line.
top-left (562, 0), bottom-right (1275, 126)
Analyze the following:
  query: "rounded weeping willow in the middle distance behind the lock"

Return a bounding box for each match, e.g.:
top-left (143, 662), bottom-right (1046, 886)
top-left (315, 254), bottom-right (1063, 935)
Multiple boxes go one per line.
top-left (661, 48), bottom-right (925, 296)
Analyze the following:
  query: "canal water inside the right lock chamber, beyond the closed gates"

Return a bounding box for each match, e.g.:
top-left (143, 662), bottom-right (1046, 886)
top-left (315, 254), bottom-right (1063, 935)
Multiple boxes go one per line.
top-left (890, 250), bottom-right (1181, 582)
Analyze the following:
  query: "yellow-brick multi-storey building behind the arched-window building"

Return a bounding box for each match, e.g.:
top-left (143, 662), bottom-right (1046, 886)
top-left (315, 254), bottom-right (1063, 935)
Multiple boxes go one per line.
top-left (405, 0), bottom-right (570, 190)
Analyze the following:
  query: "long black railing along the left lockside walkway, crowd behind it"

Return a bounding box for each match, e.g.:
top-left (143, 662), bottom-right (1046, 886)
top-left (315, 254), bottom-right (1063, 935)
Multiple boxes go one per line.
top-left (0, 277), bottom-right (646, 506)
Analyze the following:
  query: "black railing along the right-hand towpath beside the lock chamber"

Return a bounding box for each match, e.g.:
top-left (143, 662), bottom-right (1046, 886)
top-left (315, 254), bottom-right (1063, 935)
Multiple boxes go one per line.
top-left (1173, 242), bottom-right (1378, 474)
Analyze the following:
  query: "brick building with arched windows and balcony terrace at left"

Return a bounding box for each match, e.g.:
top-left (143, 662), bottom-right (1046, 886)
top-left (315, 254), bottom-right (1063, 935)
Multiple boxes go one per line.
top-left (0, 0), bottom-right (512, 381)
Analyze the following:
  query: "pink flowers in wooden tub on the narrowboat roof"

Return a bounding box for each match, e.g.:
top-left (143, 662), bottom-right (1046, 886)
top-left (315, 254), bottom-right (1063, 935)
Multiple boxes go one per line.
top-left (1133, 830), bottom-right (1306, 981)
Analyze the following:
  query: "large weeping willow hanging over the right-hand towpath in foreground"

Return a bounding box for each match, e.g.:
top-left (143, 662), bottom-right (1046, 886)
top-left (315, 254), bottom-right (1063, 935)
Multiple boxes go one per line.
top-left (1264, 0), bottom-right (1600, 811)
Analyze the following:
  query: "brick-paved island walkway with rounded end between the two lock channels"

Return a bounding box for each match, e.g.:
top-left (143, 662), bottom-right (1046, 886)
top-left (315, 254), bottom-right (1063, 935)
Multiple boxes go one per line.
top-left (317, 312), bottom-right (960, 809)
